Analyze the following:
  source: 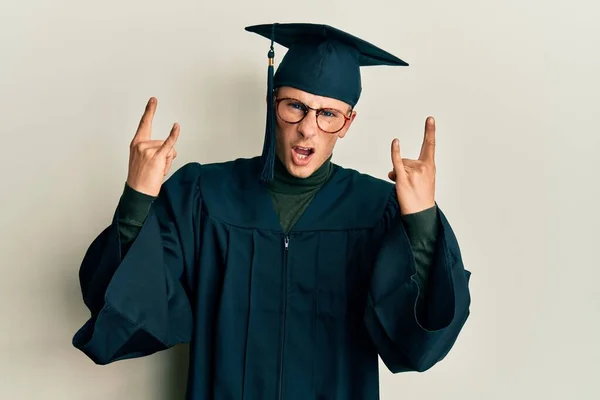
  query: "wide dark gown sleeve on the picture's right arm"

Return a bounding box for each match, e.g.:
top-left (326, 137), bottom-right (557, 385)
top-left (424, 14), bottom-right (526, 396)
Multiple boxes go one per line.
top-left (364, 191), bottom-right (471, 373)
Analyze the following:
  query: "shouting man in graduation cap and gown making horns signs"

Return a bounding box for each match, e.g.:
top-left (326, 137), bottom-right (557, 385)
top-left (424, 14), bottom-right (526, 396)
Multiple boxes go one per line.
top-left (73, 24), bottom-right (470, 400)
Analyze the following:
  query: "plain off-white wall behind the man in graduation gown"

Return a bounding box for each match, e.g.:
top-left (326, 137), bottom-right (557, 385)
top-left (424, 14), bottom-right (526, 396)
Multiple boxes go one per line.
top-left (0, 0), bottom-right (600, 400)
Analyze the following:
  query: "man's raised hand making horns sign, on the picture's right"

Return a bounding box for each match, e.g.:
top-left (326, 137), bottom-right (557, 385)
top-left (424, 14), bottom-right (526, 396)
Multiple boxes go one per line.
top-left (388, 117), bottom-right (435, 215)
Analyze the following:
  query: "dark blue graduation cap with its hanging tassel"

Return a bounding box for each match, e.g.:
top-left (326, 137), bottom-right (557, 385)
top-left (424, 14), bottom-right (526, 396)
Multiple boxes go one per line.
top-left (246, 23), bottom-right (408, 181)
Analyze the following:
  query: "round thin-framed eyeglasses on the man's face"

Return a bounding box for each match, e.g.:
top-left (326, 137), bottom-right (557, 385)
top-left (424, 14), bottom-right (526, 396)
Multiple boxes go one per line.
top-left (275, 97), bottom-right (350, 133)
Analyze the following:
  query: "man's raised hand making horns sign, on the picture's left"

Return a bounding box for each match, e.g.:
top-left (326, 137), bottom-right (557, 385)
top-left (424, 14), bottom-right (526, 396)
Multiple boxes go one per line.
top-left (127, 97), bottom-right (179, 196)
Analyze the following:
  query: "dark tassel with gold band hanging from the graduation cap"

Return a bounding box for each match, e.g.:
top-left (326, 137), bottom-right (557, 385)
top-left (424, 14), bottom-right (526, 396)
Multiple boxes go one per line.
top-left (260, 24), bottom-right (275, 182)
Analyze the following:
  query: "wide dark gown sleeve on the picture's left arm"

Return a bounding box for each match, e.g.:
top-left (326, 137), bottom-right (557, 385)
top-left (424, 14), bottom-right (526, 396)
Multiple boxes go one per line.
top-left (73, 164), bottom-right (201, 365)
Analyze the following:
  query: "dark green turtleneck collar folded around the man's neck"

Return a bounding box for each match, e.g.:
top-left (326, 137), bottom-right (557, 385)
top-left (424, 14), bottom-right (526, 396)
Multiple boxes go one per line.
top-left (269, 156), bottom-right (333, 194)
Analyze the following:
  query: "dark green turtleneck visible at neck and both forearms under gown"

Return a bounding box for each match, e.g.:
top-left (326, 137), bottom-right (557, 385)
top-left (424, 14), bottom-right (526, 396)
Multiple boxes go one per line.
top-left (118, 157), bottom-right (439, 298)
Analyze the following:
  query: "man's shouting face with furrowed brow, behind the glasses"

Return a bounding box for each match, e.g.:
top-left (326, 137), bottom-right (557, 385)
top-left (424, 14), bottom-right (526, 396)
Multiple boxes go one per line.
top-left (277, 87), bottom-right (356, 178)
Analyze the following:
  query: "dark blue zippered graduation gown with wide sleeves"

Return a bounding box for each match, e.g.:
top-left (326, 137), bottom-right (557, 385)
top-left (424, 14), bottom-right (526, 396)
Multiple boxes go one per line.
top-left (73, 158), bottom-right (470, 400)
